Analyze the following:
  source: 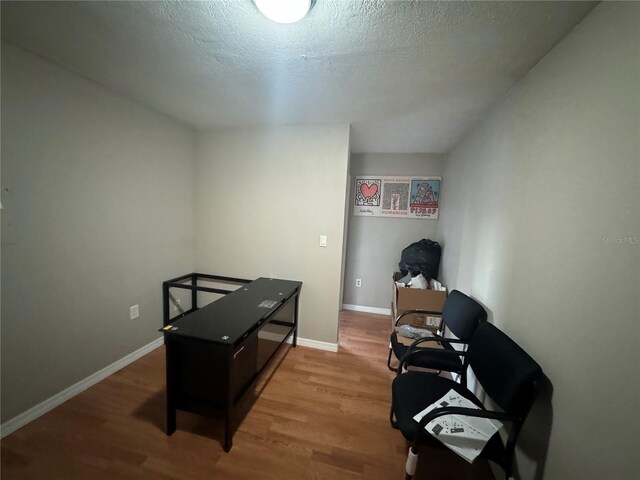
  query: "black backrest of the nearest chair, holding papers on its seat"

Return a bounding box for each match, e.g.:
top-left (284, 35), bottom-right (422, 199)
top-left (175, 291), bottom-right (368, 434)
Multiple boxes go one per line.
top-left (467, 322), bottom-right (542, 417)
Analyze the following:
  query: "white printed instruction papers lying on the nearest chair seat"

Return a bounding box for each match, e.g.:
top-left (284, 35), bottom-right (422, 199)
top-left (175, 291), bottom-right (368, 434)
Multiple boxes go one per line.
top-left (413, 390), bottom-right (502, 463)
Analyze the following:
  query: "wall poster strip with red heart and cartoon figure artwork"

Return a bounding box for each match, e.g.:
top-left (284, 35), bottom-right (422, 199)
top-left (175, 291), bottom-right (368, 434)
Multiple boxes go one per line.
top-left (353, 175), bottom-right (442, 219)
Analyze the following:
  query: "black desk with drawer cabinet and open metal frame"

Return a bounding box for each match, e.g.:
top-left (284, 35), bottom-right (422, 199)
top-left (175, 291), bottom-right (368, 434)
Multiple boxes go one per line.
top-left (162, 274), bottom-right (302, 452)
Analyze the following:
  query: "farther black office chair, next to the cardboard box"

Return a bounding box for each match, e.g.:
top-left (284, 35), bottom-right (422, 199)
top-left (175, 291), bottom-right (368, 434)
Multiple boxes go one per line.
top-left (387, 290), bottom-right (487, 373)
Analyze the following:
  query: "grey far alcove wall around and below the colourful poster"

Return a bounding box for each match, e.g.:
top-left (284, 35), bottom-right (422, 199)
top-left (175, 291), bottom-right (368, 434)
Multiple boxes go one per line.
top-left (343, 153), bottom-right (444, 309)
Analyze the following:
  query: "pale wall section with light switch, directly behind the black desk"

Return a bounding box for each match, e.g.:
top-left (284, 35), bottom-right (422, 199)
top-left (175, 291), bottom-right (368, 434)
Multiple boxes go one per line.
top-left (195, 125), bottom-right (349, 344)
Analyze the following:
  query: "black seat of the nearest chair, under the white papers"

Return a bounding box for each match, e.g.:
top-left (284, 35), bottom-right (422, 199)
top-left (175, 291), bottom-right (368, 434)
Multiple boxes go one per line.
top-left (392, 371), bottom-right (504, 465)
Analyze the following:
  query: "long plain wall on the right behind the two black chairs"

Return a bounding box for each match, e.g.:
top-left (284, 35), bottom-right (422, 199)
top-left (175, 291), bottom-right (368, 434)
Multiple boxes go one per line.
top-left (439, 2), bottom-right (640, 480)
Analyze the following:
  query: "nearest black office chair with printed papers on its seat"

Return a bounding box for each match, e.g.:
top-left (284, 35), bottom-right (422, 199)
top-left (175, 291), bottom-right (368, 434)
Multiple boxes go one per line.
top-left (392, 322), bottom-right (542, 479)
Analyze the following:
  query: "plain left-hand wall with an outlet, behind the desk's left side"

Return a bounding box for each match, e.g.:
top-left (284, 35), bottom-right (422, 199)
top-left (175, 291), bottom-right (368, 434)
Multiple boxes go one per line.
top-left (2, 44), bottom-right (194, 421)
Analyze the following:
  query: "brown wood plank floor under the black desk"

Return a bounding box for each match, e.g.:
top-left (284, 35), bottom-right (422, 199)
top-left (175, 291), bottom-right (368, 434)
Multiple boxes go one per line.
top-left (1, 312), bottom-right (496, 480)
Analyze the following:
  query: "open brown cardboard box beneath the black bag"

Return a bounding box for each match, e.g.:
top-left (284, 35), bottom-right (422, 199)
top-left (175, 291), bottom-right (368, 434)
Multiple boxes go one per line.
top-left (391, 272), bottom-right (447, 331)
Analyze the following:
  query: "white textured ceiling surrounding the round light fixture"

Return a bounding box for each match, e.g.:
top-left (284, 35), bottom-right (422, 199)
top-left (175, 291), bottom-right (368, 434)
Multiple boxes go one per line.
top-left (2, 0), bottom-right (595, 153)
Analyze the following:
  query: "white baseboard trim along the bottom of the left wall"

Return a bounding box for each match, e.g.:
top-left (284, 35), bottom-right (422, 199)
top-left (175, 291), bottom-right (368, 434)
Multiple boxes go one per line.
top-left (0, 337), bottom-right (164, 438)
